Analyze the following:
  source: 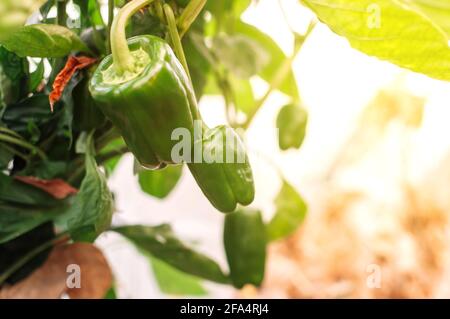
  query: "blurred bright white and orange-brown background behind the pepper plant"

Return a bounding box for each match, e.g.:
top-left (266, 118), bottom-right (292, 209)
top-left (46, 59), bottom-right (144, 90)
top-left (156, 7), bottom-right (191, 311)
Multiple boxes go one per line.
top-left (90, 0), bottom-right (450, 298)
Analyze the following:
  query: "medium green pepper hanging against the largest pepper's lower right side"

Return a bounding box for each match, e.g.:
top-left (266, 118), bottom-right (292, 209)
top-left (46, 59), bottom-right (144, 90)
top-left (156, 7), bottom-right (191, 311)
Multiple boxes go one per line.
top-left (188, 126), bottom-right (255, 213)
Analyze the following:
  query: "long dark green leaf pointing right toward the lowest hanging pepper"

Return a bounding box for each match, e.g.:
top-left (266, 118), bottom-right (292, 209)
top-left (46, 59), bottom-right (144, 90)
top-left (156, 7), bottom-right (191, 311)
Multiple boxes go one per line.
top-left (113, 225), bottom-right (228, 283)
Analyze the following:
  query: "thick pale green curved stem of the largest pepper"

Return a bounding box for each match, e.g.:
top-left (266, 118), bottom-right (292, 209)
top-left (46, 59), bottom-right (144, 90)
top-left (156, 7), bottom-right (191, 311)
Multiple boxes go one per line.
top-left (110, 0), bottom-right (154, 75)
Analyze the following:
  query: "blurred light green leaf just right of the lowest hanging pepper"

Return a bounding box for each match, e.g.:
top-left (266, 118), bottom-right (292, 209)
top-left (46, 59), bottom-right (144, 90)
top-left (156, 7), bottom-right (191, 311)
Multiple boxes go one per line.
top-left (267, 181), bottom-right (307, 240)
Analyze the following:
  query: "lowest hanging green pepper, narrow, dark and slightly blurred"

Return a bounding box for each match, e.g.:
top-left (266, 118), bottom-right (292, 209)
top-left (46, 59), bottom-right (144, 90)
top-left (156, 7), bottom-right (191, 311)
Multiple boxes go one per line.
top-left (223, 209), bottom-right (267, 288)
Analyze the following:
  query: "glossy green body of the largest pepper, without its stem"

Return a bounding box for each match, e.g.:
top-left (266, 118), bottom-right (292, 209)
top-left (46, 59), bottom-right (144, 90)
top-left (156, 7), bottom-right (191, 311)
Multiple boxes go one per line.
top-left (90, 35), bottom-right (194, 169)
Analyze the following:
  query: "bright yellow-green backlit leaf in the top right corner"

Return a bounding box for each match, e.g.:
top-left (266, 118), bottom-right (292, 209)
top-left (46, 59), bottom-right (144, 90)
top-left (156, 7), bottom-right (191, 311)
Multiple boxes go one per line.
top-left (302, 0), bottom-right (450, 80)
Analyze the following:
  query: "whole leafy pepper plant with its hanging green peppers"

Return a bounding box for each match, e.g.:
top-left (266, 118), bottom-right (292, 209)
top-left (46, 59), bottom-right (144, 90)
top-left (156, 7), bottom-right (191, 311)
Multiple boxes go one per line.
top-left (0, 0), bottom-right (450, 297)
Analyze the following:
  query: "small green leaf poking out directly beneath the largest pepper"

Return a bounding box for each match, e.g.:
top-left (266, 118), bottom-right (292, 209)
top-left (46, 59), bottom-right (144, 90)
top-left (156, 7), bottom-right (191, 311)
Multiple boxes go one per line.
top-left (139, 165), bottom-right (183, 199)
